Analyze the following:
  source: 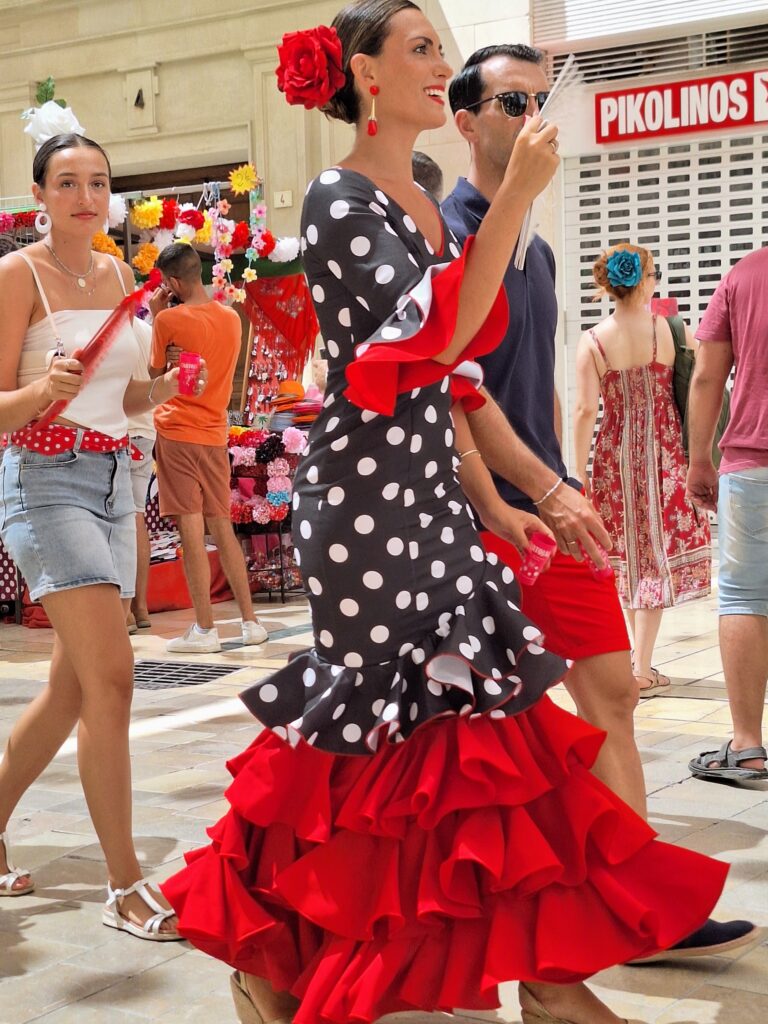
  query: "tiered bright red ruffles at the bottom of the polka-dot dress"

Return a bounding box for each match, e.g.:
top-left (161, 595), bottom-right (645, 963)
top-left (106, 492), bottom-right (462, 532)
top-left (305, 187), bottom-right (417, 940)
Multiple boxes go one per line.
top-left (163, 697), bottom-right (727, 1024)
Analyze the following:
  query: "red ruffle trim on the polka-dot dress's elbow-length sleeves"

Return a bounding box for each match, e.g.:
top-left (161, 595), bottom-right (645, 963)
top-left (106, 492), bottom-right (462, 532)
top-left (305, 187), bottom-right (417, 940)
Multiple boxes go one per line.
top-left (344, 236), bottom-right (509, 416)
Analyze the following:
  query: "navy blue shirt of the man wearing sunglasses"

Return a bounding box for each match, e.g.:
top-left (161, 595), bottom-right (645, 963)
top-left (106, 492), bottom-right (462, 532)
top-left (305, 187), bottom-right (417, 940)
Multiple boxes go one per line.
top-left (440, 178), bottom-right (578, 513)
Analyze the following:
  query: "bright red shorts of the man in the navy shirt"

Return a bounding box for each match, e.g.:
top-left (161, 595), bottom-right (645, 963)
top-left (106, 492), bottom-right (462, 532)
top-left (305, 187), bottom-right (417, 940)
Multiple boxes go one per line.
top-left (480, 530), bottom-right (630, 662)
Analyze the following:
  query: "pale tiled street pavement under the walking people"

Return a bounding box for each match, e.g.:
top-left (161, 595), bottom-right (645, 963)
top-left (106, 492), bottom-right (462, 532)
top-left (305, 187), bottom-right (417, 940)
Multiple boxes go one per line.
top-left (0, 585), bottom-right (768, 1024)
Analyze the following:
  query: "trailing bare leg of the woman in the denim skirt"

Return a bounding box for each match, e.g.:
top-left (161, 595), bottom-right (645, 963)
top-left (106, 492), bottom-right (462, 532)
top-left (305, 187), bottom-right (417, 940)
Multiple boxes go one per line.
top-left (0, 637), bottom-right (80, 889)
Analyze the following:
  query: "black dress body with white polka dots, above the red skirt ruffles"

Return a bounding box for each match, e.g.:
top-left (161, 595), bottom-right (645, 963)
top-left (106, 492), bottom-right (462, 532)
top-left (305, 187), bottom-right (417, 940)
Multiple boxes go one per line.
top-left (244, 169), bottom-right (565, 754)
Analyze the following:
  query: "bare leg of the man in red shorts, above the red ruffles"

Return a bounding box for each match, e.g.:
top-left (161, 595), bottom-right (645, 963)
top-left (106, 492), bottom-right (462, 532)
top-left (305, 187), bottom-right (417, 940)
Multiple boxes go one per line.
top-left (565, 650), bottom-right (646, 817)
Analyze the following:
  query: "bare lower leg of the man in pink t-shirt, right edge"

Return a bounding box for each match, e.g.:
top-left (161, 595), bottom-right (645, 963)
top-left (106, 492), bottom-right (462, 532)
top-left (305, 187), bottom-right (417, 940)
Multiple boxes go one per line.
top-left (713, 615), bottom-right (768, 769)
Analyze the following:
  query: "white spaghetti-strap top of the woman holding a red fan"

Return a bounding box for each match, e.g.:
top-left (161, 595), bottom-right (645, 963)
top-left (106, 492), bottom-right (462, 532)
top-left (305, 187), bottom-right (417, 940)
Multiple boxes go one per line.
top-left (16, 252), bottom-right (139, 437)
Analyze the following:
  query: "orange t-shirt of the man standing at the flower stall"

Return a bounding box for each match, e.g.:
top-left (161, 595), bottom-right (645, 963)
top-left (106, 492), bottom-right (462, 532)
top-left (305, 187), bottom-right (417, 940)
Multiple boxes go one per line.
top-left (151, 300), bottom-right (242, 444)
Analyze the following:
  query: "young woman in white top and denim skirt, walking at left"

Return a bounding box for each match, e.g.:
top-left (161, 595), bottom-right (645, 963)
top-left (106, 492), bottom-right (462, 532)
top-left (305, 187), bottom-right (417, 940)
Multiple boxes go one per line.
top-left (0, 135), bottom-right (204, 941)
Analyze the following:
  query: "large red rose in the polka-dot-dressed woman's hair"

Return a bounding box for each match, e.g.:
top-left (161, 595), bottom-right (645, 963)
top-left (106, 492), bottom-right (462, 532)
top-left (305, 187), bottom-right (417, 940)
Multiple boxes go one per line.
top-left (275, 25), bottom-right (346, 111)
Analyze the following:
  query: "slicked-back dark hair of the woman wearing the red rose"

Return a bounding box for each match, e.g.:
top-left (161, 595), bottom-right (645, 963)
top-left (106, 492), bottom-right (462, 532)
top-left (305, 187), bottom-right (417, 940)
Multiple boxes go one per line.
top-left (322, 0), bottom-right (421, 125)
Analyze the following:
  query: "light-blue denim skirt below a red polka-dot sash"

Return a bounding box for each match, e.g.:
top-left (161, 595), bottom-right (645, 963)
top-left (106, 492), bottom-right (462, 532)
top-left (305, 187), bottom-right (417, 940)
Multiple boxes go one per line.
top-left (0, 442), bottom-right (136, 601)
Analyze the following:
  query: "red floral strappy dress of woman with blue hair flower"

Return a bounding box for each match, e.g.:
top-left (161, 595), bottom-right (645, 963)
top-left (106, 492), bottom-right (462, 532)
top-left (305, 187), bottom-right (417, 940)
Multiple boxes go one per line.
top-left (590, 316), bottom-right (712, 608)
